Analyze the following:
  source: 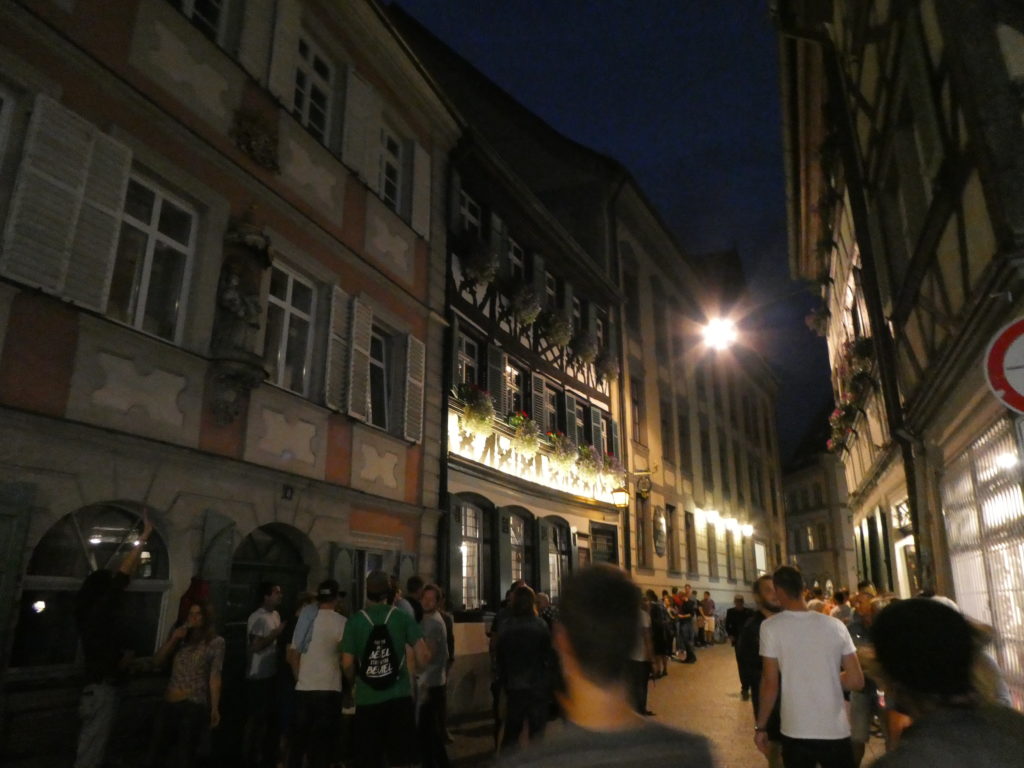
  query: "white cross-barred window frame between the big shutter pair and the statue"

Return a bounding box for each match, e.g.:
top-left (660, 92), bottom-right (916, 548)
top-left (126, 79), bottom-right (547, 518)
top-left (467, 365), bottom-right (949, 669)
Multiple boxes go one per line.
top-left (110, 176), bottom-right (200, 344)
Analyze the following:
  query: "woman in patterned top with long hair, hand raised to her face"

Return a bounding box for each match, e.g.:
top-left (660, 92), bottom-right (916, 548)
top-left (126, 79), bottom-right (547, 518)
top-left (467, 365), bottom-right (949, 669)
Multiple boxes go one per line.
top-left (150, 602), bottom-right (224, 768)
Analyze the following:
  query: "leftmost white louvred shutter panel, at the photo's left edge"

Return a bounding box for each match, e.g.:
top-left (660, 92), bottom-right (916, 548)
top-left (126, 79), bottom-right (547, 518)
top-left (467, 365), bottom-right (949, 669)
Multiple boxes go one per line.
top-left (0, 94), bottom-right (90, 294)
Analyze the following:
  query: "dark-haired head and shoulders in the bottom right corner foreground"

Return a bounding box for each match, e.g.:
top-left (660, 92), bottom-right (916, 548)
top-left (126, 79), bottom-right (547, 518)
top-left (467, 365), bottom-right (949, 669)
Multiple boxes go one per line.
top-left (871, 598), bottom-right (1024, 768)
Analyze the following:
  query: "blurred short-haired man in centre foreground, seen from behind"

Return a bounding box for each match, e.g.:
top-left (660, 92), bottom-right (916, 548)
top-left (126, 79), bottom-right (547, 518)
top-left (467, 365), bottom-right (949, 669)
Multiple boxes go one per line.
top-left (505, 564), bottom-right (714, 768)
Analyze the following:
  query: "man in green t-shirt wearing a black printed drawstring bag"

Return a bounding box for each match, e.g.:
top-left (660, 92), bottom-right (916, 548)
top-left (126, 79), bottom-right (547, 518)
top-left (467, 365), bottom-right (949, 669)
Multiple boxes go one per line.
top-left (341, 570), bottom-right (430, 768)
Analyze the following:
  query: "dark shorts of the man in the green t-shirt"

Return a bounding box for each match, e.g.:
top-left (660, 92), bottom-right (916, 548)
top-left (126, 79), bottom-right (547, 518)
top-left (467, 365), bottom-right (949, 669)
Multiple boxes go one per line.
top-left (352, 696), bottom-right (420, 768)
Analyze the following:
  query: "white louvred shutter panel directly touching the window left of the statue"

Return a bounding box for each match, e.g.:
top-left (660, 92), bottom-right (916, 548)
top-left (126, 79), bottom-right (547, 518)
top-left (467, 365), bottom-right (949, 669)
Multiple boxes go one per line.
top-left (63, 134), bottom-right (131, 312)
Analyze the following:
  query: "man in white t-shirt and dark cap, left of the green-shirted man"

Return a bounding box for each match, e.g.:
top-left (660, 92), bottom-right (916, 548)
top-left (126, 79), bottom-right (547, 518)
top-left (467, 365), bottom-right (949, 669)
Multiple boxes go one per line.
top-left (288, 579), bottom-right (346, 768)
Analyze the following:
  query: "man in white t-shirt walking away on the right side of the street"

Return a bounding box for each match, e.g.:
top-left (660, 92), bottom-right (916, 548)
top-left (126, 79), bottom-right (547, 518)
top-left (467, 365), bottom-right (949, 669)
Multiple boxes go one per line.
top-left (754, 565), bottom-right (864, 768)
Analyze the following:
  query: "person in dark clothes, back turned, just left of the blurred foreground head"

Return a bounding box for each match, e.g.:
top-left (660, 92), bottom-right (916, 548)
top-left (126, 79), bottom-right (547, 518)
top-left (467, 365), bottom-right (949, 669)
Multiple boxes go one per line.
top-left (496, 585), bottom-right (553, 749)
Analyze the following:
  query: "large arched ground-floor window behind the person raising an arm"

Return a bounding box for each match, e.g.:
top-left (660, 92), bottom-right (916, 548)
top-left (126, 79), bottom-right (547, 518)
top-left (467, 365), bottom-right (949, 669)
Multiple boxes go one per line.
top-left (10, 504), bottom-right (169, 668)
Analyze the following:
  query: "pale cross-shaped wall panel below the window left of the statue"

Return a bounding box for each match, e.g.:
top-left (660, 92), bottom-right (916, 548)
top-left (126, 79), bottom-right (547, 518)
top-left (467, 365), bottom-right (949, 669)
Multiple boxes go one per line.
top-left (92, 352), bottom-right (187, 427)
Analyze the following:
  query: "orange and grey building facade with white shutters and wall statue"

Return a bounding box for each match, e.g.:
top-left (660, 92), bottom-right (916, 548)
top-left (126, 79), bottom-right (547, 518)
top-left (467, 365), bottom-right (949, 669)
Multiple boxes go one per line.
top-left (0, 0), bottom-right (459, 765)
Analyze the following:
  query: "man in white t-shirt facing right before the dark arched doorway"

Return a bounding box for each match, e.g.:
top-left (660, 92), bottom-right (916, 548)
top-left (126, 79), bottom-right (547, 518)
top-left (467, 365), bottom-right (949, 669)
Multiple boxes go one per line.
top-left (242, 582), bottom-right (282, 768)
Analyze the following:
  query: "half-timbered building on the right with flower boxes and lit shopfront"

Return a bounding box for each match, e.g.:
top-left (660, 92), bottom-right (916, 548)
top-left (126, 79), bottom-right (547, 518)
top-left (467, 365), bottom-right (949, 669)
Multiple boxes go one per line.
top-left (773, 0), bottom-right (1024, 706)
